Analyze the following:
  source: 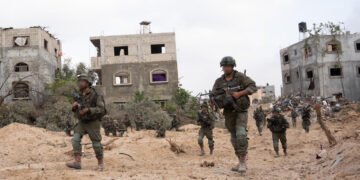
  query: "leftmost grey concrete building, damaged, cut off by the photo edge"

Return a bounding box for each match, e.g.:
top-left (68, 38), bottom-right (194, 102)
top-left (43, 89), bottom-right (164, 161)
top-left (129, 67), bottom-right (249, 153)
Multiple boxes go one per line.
top-left (0, 26), bottom-right (61, 104)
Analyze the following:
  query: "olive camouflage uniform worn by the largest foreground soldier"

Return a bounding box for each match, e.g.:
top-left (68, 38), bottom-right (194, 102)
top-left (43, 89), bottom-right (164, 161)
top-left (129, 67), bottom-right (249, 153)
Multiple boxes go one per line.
top-left (212, 70), bottom-right (257, 157)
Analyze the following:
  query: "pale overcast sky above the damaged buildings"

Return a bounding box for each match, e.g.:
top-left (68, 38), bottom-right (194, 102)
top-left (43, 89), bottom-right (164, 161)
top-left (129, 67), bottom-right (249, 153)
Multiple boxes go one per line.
top-left (0, 0), bottom-right (360, 95)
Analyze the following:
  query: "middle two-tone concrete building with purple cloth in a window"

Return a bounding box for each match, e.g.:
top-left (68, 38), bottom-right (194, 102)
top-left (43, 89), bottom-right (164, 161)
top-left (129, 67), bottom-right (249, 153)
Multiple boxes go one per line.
top-left (90, 21), bottom-right (178, 104)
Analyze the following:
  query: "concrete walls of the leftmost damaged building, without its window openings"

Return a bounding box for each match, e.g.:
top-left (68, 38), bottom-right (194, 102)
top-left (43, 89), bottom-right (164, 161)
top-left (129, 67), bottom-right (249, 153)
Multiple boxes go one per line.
top-left (0, 28), bottom-right (61, 104)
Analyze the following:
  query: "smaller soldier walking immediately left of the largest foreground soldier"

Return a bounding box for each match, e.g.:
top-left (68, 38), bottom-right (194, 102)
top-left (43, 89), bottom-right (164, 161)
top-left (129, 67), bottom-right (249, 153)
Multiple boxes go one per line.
top-left (197, 103), bottom-right (215, 156)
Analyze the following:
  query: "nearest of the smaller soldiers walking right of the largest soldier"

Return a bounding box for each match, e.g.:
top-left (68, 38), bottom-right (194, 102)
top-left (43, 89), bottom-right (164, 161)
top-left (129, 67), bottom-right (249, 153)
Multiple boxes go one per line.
top-left (267, 108), bottom-right (289, 157)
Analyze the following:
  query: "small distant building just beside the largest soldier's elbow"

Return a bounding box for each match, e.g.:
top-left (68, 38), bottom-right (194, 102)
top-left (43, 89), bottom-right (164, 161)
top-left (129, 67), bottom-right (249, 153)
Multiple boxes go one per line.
top-left (250, 84), bottom-right (276, 104)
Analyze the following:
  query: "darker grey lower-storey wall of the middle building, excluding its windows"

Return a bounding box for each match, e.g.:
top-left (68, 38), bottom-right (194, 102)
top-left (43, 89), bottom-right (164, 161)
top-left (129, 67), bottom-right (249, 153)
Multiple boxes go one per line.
top-left (99, 61), bottom-right (178, 103)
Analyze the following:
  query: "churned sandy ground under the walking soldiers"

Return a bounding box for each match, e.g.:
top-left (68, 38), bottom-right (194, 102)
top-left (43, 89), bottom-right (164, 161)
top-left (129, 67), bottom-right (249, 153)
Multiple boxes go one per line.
top-left (0, 107), bottom-right (360, 179)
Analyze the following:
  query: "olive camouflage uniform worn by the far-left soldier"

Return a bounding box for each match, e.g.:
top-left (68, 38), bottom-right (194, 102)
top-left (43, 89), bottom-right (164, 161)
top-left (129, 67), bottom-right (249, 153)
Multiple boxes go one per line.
top-left (72, 88), bottom-right (105, 157)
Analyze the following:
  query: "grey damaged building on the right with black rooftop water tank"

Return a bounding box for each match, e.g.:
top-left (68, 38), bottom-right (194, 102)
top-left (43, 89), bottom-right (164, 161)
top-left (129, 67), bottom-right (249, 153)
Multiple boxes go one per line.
top-left (280, 32), bottom-right (360, 101)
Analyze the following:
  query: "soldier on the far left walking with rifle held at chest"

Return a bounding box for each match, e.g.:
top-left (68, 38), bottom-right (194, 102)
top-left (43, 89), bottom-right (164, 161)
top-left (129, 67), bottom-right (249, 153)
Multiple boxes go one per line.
top-left (66, 74), bottom-right (106, 170)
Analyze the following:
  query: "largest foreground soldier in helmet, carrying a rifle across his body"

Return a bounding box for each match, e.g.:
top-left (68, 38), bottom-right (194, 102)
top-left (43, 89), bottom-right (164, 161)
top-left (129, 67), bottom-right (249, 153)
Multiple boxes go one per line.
top-left (212, 56), bottom-right (257, 173)
